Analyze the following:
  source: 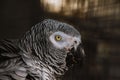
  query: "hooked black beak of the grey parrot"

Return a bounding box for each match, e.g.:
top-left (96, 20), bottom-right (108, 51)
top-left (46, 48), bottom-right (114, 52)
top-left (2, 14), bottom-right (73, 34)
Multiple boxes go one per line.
top-left (66, 44), bottom-right (85, 67)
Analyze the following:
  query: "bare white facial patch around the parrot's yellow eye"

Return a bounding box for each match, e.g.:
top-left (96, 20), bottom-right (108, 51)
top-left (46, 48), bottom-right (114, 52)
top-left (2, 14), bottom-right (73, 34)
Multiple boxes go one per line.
top-left (49, 31), bottom-right (80, 49)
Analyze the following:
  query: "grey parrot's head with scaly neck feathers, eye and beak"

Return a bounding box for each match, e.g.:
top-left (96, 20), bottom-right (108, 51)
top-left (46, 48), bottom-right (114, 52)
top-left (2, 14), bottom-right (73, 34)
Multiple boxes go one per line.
top-left (19, 19), bottom-right (85, 75)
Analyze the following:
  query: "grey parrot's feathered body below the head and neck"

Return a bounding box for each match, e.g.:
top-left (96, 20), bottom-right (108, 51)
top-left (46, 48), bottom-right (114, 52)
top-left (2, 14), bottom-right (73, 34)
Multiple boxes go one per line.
top-left (0, 40), bottom-right (56, 80)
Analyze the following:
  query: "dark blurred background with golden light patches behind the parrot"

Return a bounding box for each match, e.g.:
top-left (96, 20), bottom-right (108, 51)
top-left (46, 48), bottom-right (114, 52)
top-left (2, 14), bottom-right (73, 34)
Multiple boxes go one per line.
top-left (0, 0), bottom-right (120, 80)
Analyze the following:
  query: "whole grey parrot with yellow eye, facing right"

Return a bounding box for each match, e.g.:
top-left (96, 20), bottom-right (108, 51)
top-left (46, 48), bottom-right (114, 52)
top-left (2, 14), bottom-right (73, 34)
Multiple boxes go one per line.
top-left (0, 19), bottom-right (85, 80)
